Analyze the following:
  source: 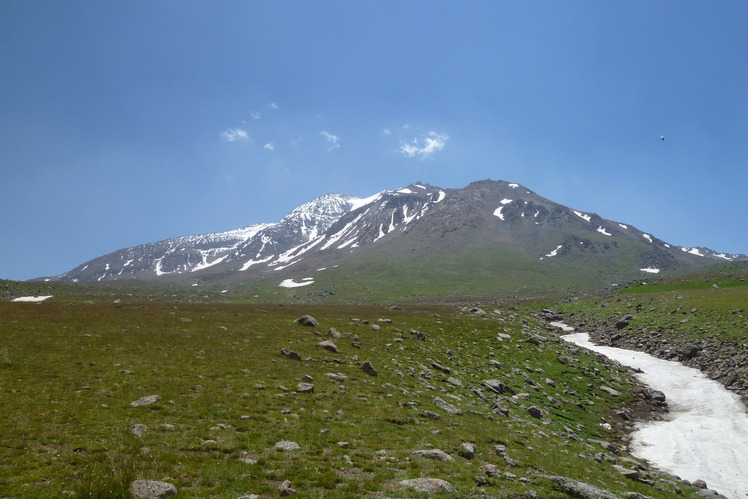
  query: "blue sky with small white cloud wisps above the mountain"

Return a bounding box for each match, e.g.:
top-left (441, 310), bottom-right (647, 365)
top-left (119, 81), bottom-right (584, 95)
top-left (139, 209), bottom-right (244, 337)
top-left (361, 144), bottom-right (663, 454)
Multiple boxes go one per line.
top-left (0, 0), bottom-right (748, 280)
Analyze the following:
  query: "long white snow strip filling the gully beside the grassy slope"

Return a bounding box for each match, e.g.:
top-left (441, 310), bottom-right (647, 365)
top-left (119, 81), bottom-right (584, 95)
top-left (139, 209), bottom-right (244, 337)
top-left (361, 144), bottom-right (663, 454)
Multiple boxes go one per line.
top-left (557, 330), bottom-right (748, 499)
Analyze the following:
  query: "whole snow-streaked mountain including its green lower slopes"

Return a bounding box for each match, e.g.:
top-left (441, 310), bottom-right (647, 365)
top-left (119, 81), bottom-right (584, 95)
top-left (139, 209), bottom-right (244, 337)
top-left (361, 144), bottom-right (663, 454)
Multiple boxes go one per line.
top-left (45, 180), bottom-right (748, 294)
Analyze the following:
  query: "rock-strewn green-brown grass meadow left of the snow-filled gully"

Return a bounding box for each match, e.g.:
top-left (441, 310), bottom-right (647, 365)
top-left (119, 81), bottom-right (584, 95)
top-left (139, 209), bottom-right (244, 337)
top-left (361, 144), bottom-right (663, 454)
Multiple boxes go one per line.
top-left (0, 295), bottom-right (708, 498)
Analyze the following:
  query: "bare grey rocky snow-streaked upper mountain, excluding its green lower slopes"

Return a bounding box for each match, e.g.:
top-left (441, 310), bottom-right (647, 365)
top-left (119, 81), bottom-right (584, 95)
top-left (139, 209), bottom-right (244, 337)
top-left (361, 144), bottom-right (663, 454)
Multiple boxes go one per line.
top-left (49, 180), bottom-right (746, 285)
